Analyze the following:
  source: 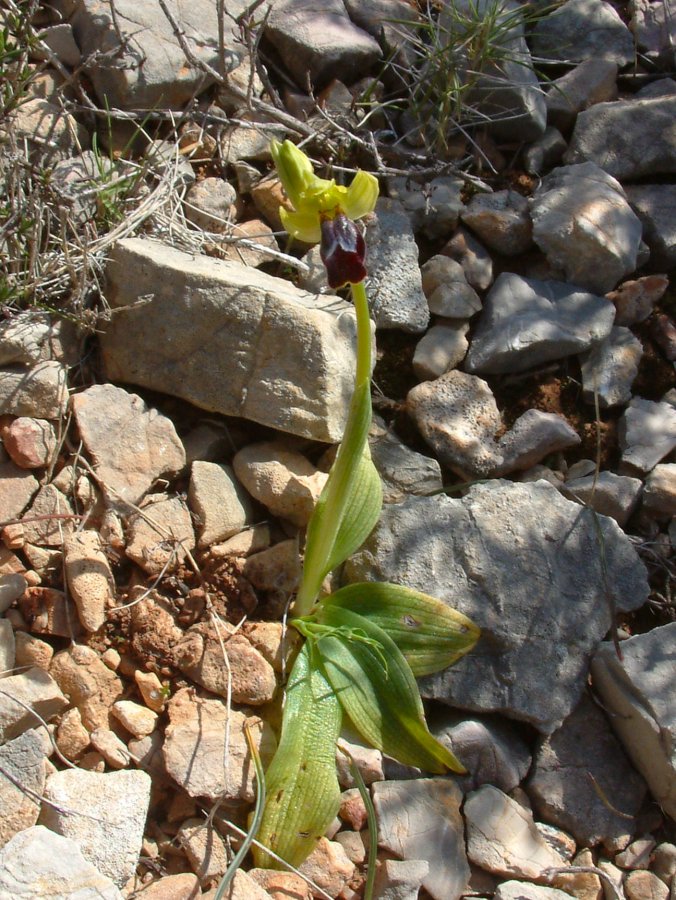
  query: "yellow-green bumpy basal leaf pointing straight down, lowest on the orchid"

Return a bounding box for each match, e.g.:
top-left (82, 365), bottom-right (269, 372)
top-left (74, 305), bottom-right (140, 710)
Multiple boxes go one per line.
top-left (253, 642), bottom-right (342, 869)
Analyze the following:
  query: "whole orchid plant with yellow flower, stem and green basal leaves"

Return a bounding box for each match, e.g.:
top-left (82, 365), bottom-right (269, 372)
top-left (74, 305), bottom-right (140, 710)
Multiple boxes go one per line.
top-left (254, 141), bottom-right (479, 868)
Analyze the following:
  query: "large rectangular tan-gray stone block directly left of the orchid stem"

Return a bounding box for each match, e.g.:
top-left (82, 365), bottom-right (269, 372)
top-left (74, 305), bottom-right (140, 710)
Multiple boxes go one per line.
top-left (101, 238), bottom-right (360, 442)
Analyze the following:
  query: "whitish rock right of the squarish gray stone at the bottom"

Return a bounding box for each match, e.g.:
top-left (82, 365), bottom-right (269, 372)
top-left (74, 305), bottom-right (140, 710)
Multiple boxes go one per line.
top-left (464, 784), bottom-right (564, 881)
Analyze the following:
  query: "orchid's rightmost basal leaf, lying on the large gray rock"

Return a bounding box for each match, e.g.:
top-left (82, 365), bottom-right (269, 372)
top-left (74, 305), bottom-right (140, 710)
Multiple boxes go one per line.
top-left (321, 581), bottom-right (480, 678)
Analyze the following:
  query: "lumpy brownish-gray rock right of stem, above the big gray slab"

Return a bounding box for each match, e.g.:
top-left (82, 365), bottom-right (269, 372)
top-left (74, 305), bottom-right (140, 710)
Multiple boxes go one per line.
top-left (406, 369), bottom-right (502, 478)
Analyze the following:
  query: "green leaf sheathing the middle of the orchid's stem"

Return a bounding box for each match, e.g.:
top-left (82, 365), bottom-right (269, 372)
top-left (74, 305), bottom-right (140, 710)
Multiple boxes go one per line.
top-left (296, 379), bottom-right (382, 615)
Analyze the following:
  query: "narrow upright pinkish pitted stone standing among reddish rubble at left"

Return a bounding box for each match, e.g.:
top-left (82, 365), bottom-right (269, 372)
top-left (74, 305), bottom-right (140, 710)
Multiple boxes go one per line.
top-left (63, 531), bottom-right (115, 631)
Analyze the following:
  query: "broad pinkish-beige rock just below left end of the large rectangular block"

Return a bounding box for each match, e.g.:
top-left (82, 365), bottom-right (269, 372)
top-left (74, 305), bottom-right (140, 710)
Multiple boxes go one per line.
top-left (72, 384), bottom-right (185, 506)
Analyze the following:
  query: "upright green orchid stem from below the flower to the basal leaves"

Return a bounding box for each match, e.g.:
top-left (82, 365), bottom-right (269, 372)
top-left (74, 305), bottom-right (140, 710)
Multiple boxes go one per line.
top-left (293, 281), bottom-right (371, 617)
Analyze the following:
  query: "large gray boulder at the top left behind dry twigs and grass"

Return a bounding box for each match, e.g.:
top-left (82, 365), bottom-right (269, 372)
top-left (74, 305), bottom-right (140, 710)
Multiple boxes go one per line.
top-left (72, 0), bottom-right (247, 109)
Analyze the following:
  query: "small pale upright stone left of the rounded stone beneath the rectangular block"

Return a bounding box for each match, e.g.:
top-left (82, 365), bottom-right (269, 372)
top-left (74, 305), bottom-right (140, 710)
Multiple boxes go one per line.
top-left (188, 462), bottom-right (253, 547)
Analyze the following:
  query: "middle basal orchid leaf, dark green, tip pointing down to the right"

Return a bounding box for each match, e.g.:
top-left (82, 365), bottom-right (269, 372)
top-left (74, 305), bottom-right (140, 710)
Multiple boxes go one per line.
top-left (313, 604), bottom-right (466, 774)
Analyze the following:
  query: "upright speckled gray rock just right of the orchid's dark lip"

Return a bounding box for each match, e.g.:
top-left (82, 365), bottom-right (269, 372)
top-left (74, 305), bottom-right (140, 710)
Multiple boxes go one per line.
top-left (365, 197), bottom-right (430, 334)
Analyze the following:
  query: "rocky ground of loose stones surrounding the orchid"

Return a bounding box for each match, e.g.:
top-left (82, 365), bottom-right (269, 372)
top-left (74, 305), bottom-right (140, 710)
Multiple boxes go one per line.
top-left (0, 0), bottom-right (676, 900)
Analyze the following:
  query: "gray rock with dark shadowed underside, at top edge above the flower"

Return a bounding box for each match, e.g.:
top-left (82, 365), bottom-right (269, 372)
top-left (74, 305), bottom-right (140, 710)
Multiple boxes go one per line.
top-left (265, 0), bottom-right (382, 90)
